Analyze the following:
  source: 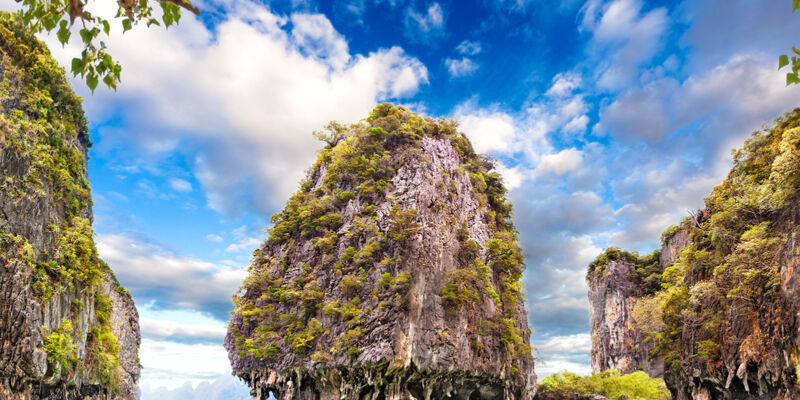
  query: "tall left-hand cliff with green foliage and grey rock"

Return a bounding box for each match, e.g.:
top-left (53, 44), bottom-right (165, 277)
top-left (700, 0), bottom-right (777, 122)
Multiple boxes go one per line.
top-left (0, 13), bottom-right (140, 399)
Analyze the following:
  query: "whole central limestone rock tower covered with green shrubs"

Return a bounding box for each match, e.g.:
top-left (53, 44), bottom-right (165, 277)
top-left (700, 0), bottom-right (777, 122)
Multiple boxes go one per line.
top-left (225, 104), bottom-right (536, 399)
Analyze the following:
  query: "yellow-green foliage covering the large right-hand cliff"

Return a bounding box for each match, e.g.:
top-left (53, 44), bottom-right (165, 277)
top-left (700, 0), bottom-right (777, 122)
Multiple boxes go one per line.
top-left (655, 110), bottom-right (800, 370)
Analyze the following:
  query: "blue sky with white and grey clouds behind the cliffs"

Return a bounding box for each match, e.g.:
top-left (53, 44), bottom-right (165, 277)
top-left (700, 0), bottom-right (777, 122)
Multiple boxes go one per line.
top-left (6, 0), bottom-right (800, 399)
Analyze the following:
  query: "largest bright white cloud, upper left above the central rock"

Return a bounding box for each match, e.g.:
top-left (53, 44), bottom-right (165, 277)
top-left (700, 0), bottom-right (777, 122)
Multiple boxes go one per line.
top-left (42, 2), bottom-right (432, 219)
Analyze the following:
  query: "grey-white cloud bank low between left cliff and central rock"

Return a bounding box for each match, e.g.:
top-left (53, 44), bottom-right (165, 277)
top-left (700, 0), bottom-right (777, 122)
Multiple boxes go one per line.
top-left (97, 234), bottom-right (247, 321)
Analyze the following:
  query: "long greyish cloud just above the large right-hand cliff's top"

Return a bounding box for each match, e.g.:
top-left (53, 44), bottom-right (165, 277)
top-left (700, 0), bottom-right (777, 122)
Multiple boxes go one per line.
top-left (599, 55), bottom-right (800, 144)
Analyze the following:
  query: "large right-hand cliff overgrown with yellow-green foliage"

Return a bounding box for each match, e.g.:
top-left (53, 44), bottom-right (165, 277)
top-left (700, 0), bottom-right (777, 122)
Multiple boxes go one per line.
top-left (592, 110), bottom-right (800, 400)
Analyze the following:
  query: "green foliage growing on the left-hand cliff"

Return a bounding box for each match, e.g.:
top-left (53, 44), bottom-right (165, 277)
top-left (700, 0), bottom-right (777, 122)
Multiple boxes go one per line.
top-left (0, 13), bottom-right (126, 387)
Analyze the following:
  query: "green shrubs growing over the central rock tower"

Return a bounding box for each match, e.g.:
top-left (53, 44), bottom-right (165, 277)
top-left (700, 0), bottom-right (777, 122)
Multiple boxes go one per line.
top-left (229, 104), bottom-right (531, 372)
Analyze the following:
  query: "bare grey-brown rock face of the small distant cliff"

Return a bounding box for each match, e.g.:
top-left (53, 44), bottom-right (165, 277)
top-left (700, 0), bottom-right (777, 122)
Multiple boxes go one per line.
top-left (587, 259), bottom-right (664, 377)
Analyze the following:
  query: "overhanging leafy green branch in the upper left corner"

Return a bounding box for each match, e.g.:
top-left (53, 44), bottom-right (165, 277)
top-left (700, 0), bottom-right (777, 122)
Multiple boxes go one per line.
top-left (16, 0), bottom-right (200, 91)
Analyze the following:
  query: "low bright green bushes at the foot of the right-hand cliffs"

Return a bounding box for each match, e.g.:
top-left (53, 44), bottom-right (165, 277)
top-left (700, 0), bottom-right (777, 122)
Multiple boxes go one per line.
top-left (538, 370), bottom-right (671, 400)
